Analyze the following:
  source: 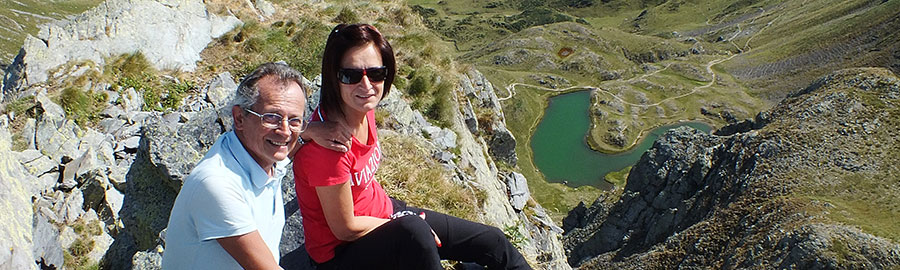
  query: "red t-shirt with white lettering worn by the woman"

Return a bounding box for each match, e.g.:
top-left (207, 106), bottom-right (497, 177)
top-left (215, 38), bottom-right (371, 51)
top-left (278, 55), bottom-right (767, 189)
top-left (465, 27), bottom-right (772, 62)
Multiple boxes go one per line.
top-left (294, 110), bottom-right (393, 263)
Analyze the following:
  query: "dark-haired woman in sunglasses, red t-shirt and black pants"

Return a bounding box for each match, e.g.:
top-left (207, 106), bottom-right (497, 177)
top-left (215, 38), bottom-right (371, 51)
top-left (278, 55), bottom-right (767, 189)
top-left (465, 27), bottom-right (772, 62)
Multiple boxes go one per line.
top-left (294, 24), bottom-right (531, 269)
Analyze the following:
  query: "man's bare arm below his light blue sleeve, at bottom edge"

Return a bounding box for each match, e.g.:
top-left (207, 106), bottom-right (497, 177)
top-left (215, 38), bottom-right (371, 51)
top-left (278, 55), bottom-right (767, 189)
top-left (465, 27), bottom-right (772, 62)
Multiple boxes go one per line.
top-left (216, 231), bottom-right (281, 270)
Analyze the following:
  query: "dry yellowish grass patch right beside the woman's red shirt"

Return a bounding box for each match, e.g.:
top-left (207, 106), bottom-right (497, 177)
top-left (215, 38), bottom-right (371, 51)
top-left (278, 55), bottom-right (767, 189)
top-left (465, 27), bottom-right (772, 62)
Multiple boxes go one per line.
top-left (378, 133), bottom-right (486, 220)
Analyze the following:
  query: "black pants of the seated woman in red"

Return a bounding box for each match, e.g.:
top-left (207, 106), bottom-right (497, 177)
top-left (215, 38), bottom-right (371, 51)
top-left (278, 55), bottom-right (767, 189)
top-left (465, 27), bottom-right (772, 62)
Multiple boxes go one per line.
top-left (318, 198), bottom-right (531, 270)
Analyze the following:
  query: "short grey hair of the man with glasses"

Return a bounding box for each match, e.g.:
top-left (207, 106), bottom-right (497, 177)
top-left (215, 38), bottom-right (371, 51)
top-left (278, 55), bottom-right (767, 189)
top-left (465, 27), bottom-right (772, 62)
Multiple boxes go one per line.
top-left (231, 62), bottom-right (306, 109)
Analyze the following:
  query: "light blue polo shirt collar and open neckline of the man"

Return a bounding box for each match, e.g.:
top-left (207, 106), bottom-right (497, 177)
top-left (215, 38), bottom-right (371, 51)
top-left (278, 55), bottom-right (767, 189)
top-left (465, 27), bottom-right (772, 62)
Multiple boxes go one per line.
top-left (225, 131), bottom-right (291, 188)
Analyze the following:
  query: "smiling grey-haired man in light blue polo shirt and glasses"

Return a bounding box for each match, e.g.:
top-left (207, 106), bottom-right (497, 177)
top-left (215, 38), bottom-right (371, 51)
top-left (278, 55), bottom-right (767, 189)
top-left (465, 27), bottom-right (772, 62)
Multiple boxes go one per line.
top-left (162, 63), bottom-right (349, 270)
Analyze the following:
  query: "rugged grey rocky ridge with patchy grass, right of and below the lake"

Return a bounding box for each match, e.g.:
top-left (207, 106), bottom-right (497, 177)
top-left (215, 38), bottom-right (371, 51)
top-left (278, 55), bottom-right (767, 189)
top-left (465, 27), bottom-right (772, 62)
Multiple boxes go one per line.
top-left (566, 69), bottom-right (900, 269)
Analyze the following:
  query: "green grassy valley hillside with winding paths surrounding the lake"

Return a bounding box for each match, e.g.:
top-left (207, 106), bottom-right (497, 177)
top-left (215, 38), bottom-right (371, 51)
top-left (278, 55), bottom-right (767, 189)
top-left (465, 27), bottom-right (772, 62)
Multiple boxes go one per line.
top-left (410, 0), bottom-right (900, 217)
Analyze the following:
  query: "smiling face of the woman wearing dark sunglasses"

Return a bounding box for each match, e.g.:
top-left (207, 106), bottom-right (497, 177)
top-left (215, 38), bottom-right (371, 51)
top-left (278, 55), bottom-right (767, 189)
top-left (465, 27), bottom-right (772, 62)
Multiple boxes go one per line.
top-left (338, 42), bottom-right (384, 117)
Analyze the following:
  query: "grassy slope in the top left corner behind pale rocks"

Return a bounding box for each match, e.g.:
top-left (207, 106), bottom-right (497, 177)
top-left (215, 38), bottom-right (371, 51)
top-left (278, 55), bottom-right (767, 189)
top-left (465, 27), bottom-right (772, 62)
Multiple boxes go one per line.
top-left (0, 0), bottom-right (103, 64)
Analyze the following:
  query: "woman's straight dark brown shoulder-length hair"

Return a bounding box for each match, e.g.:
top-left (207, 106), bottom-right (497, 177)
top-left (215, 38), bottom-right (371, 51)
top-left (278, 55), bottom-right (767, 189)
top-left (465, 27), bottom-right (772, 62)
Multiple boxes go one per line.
top-left (319, 24), bottom-right (397, 117)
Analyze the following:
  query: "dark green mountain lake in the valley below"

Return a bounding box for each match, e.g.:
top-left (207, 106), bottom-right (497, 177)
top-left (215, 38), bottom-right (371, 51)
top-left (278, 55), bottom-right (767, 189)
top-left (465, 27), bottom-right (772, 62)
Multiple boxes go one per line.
top-left (531, 91), bottom-right (711, 189)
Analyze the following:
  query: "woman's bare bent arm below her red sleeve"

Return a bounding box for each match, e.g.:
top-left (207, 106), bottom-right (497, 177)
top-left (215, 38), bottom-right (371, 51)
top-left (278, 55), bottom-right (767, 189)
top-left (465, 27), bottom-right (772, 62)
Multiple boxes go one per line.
top-left (316, 181), bottom-right (389, 241)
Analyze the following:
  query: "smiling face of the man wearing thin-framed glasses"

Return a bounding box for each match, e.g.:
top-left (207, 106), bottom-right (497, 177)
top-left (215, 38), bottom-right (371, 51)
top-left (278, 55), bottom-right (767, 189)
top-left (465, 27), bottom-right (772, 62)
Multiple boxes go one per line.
top-left (232, 75), bottom-right (306, 172)
